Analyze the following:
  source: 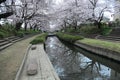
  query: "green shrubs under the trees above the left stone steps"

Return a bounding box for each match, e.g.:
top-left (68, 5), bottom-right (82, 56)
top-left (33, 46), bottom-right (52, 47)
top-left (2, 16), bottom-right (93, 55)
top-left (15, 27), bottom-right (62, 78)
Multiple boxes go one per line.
top-left (0, 23), bottom-right (40, 39)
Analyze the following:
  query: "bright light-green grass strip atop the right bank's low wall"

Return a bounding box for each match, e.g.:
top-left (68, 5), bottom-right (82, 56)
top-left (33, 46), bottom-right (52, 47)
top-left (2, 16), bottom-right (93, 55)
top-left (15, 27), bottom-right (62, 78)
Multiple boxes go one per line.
top-left (79, 38), bottom-right (120, 52)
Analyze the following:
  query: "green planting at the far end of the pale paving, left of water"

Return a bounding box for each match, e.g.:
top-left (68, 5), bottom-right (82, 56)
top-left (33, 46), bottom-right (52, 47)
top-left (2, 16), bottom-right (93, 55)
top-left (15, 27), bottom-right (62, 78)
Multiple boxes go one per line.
top-left (30, 33), bottom-right (47, 44)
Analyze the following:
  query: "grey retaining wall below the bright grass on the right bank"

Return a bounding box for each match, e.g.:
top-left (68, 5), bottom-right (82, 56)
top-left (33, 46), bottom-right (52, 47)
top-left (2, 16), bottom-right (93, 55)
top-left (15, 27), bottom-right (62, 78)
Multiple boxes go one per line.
top-left (74, 41), bottom-right (120, 62)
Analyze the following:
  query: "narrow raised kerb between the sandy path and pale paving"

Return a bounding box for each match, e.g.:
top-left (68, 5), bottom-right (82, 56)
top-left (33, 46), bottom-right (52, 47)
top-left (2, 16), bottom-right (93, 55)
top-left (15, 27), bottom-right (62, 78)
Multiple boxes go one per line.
top-left (14, 44), bottom-right (32, 80)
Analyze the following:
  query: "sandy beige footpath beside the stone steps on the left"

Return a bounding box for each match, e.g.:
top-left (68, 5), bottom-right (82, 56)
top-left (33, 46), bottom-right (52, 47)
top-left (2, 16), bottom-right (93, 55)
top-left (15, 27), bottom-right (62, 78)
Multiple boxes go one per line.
top-left (0, 35), bottom-right (38, 80)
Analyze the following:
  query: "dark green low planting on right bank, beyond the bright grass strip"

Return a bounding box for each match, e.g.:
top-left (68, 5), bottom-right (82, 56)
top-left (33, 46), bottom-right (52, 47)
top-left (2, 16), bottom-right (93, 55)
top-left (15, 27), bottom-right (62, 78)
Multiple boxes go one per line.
top-left (57, 33), bottom-right (83, 42)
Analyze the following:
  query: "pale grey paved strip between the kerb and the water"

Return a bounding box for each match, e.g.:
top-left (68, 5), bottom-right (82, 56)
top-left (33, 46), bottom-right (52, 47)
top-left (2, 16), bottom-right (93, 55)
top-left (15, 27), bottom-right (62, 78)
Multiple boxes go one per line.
top-left (19, 45), bottom-right (60, 80)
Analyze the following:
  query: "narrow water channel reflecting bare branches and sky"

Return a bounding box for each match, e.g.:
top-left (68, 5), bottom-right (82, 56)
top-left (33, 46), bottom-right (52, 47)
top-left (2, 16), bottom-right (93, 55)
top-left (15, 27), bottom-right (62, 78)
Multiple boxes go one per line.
top-left (45, 37), bottom-right (120, 80)
